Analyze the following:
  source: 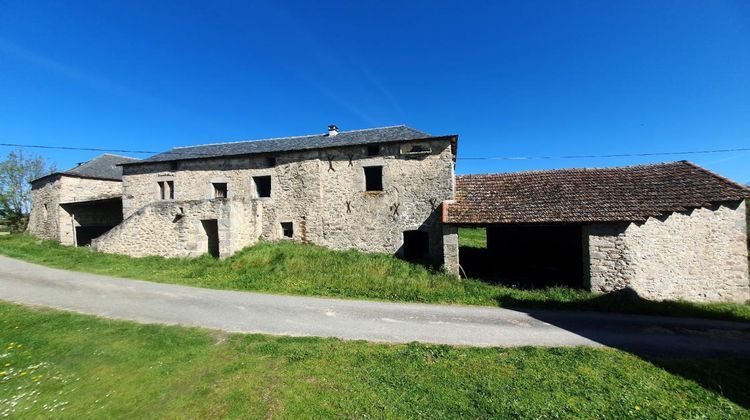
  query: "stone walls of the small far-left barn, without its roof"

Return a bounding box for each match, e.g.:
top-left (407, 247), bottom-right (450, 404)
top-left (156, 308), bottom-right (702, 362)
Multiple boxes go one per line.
top-left (28, 174), bottom-right (122, 245)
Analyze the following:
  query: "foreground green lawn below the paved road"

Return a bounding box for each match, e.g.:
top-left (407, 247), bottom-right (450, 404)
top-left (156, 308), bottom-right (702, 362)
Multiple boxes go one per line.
top-left (0, 303), bottom-right (750, 419)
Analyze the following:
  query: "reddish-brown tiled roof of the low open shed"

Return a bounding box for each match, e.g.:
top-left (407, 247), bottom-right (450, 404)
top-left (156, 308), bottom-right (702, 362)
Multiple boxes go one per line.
top-left (443, 161), bottom-right (750, 224)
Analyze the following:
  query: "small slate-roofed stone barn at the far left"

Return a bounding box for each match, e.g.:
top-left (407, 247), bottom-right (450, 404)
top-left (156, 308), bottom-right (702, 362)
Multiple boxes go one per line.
top-left (28, 154), bottom-right (137, 245)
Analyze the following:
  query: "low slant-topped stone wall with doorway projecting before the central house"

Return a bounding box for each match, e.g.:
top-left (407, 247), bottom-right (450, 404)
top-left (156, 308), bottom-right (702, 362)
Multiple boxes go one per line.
top-left (91, 199), bottom-right (262, 258)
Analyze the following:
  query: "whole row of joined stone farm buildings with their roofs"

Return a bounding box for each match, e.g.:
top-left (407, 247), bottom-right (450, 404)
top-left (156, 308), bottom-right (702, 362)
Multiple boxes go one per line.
top-left (29, 126), bottom-right (750, 302)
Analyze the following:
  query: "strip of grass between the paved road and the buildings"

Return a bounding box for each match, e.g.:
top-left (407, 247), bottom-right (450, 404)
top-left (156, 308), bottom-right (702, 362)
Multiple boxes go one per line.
top-left (0, 235), bottom-right (750, 321)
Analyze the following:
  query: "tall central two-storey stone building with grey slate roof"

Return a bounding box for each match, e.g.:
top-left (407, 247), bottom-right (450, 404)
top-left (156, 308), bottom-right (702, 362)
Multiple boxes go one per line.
top-left (92, 126), bottom-right (457, 265)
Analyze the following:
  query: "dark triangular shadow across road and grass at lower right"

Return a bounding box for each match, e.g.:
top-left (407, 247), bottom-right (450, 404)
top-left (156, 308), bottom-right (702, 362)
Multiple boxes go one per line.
top-left (498, 289), bottom-right (750, 408)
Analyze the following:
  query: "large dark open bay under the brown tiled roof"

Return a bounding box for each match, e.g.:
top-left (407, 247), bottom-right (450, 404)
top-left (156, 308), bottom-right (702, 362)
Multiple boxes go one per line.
top-left (459, 224), bottom-right (587, 289)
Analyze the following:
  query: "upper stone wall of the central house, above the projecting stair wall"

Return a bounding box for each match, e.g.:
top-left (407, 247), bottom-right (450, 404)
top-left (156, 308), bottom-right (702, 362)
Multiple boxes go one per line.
top-left (111, 139), bottom-right (454, 268)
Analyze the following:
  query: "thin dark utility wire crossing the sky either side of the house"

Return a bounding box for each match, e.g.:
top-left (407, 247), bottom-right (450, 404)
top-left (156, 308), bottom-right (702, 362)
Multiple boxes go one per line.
top-left (0, 143), bottom-right (750, 160)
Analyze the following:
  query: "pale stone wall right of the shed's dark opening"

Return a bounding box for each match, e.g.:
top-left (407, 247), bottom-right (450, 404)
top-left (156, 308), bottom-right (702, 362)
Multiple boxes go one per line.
top-left (584, 202), bottom-right (750, 302)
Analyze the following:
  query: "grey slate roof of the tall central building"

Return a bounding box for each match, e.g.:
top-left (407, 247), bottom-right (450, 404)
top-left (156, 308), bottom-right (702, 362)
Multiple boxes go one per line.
top-left (128, 125), bottom-right (455, 164)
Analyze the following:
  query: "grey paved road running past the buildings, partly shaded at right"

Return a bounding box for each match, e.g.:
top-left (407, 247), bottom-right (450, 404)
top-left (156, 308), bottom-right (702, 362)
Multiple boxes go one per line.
top-left (0, 257), bottom-right (750, 355)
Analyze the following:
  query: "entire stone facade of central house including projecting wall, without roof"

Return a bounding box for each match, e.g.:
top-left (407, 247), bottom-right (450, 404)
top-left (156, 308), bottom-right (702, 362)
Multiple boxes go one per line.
top-left (92, 138), bottom-right (458, 271)
